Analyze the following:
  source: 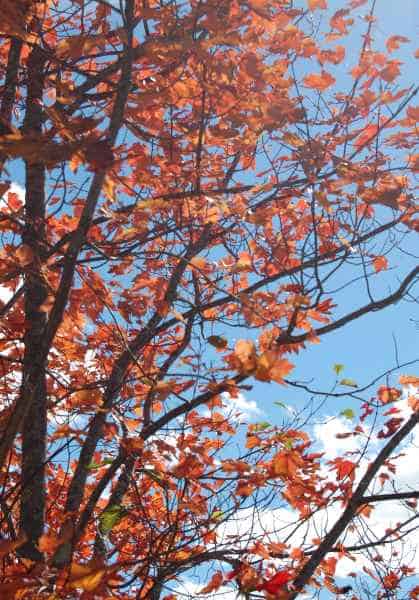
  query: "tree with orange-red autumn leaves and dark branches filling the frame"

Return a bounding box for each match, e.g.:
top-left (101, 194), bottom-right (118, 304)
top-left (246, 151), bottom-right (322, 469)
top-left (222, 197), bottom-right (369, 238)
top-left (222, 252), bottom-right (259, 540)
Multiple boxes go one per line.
top-left (0, 0), bottom-right (419, 600)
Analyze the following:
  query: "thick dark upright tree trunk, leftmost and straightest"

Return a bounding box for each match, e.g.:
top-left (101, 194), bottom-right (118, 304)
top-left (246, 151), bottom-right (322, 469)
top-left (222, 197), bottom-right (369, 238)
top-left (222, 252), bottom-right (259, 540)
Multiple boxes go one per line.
top-left (20, 47), bottom-right (48, 560)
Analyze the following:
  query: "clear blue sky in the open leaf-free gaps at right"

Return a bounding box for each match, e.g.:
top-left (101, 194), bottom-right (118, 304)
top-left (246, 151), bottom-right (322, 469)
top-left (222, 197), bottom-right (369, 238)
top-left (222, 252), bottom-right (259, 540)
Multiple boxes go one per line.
top-left (249, 0), bottom-right (419, 416)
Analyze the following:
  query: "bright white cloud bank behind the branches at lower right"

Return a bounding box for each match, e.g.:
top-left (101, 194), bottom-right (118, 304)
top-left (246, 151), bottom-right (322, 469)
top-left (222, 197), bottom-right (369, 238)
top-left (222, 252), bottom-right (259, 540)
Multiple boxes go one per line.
top-left (206, 394), bottom-right (419, 578)
